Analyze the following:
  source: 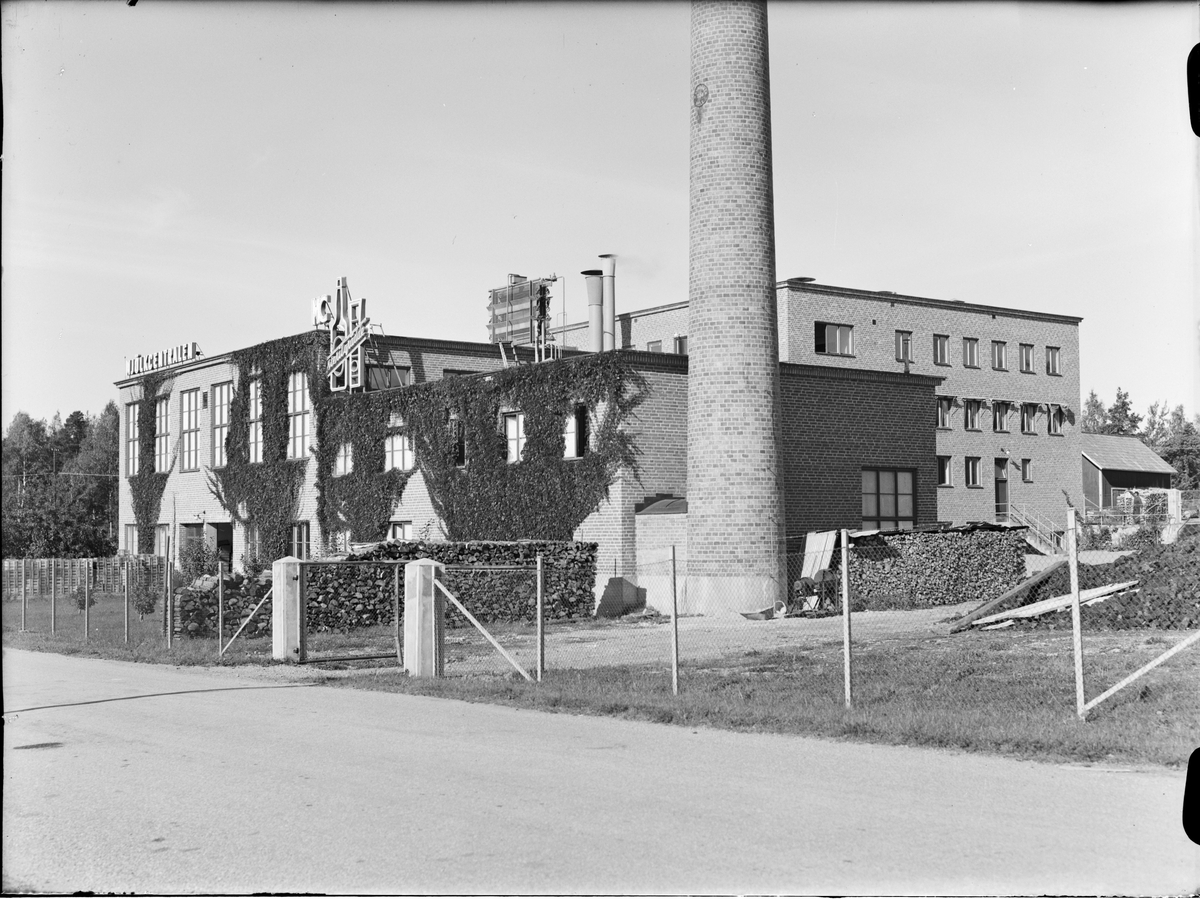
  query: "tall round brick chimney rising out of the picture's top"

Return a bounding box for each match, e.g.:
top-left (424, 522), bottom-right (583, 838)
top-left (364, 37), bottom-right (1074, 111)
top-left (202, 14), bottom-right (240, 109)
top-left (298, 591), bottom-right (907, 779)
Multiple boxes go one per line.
top-left (685, 0), bottom-right (787, 612)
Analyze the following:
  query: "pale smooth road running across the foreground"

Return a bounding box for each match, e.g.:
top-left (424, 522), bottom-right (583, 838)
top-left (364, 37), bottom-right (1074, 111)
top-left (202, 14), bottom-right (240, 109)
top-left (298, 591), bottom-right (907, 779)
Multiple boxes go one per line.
top-left (2, 649), bottom-right (1200, 894)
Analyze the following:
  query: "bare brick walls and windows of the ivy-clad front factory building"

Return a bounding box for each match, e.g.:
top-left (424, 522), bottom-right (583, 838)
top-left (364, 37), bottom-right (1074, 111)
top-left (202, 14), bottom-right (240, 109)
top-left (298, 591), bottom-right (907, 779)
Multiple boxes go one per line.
top-left (116, 288), bottom-right (945, 611)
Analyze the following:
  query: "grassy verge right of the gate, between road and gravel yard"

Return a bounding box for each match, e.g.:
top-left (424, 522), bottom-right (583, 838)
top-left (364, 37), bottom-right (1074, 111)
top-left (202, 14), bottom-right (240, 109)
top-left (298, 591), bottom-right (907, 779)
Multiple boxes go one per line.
top-left (321, 631), bottom-right (1200, 767)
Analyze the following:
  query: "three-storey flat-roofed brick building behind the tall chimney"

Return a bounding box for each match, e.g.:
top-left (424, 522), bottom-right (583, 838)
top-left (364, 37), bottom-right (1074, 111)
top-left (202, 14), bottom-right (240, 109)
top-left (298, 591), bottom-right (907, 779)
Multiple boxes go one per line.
top-left (556, 278), bottom-right (1084, 534)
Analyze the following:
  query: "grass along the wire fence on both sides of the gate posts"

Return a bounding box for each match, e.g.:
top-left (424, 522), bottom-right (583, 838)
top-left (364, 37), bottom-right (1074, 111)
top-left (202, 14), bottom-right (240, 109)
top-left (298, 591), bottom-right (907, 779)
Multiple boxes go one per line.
top-left (2, 597), bottom-right (1200, 767)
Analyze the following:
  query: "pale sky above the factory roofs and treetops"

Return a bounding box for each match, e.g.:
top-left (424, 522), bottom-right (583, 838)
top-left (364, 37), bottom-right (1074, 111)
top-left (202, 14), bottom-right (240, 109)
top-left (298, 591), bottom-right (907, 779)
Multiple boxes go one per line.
top-left (0, 0), bottom-right (1200, 426)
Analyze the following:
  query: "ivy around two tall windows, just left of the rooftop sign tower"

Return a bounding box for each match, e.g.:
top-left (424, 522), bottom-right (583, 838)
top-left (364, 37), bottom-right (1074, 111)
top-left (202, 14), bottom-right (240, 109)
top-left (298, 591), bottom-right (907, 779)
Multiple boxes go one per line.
top-left (209, 331), bottom-right (329, 559)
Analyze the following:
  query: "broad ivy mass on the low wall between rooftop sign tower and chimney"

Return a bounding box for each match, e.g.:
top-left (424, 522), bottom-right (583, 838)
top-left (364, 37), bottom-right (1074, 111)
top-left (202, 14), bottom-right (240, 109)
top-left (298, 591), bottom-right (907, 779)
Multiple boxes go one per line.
top-left (317, 353), bottom-right (646, 541)
